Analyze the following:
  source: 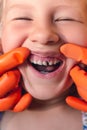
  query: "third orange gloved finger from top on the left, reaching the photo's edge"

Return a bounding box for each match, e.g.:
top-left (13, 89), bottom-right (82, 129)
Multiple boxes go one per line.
top-left (0, 88), bottom-right (21, 111)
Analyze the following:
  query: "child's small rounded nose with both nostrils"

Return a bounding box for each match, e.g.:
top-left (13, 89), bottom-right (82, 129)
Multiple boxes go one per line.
top-left (29, 26), bottom-right (59, 44)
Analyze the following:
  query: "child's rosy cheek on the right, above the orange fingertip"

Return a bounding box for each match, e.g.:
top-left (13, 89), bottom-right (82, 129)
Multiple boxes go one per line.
top-left (58, 25), bottom-right (87, 46)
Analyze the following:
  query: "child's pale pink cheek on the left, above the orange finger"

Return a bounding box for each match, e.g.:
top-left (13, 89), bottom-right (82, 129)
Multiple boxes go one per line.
top-left (1, 25), bottom-right (26, 52)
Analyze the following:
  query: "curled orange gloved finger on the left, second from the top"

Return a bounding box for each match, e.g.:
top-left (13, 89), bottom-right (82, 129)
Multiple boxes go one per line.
top-left (0, 70), bottom-right (20, 98)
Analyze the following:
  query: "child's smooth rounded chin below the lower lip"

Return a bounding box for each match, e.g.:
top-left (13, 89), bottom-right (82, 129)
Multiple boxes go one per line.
top-left (20, 71), bottom-right (72, 100)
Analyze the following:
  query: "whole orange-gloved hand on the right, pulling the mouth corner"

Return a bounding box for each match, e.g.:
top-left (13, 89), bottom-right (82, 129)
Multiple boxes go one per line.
top-left (60, 44), bottom-right (87, 112)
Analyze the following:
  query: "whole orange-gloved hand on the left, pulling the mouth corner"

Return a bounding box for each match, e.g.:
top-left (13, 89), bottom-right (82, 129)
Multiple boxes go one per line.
top-left (0, 47), bottom-right (32, 112)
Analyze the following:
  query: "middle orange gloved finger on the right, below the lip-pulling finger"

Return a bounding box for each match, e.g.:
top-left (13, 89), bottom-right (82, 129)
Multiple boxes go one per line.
top-left (70, 66), bottom-right (87, 101)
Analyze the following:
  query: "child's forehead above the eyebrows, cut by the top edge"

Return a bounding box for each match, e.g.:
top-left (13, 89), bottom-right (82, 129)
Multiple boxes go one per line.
top-left (3, 0), bottom-right (87, 15)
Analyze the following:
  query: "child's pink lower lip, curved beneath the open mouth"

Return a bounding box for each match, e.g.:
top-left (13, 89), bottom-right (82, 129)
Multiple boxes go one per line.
top-left (29, 63), bottom-right (65, 79)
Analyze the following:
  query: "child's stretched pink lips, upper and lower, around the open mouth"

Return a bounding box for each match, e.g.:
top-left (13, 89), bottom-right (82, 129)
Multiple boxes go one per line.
top-left (27, 52), bottom-right (65, 79)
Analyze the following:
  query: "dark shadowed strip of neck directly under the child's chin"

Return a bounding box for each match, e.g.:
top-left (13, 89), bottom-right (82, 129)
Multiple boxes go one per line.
top-left (29, 91), bottom-right (69, 110)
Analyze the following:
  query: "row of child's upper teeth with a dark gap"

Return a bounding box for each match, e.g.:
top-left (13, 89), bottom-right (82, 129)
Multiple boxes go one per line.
top-left (30, 59), bottom-right (60, 66)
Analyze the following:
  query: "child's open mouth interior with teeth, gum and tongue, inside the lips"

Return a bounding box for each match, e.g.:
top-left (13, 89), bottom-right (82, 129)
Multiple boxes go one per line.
top-left (30, 56), bottom-right (63, 74)
